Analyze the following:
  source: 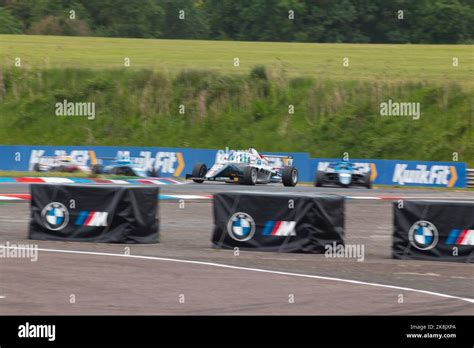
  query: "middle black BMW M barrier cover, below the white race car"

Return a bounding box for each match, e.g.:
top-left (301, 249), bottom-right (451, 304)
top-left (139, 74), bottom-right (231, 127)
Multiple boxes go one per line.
top-left (212, 192), bottom-right (344, 253)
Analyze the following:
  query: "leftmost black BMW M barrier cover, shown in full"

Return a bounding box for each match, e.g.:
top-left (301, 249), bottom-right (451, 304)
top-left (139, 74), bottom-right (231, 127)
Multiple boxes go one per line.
top-left (29, 184), bottom-right (159, 243)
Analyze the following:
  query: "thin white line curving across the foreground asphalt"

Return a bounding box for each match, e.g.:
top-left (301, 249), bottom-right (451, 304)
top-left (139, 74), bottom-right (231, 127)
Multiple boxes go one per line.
top-left (0, 245), bottom-right (474, 304)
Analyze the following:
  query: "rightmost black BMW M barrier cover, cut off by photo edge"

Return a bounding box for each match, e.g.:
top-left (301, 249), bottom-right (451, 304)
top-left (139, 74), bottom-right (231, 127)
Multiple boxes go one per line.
top-left (392, 201), bottom-right (474, 262)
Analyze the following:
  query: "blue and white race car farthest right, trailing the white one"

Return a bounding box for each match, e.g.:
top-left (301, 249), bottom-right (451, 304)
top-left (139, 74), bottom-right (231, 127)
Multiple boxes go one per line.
top-left (314, 161), bottom-right (372, 189)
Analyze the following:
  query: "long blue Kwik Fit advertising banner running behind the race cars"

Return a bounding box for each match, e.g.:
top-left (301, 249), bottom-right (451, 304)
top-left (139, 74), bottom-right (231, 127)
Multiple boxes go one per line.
top-left (0, 145), bottom-right (466, 187)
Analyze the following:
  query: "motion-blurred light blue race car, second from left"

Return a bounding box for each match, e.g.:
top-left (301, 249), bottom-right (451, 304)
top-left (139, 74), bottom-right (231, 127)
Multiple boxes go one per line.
top-left (92, 154), bottom-right (157, 177)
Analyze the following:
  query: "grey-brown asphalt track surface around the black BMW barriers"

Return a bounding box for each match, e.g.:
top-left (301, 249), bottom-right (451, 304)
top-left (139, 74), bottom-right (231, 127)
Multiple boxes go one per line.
top-left (0, 183), bottom-right (474, 315)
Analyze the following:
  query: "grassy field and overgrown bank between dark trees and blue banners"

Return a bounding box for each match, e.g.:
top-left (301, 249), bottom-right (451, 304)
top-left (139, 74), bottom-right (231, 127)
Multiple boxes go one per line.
top-left (0, 35), bottom-right (474, 165)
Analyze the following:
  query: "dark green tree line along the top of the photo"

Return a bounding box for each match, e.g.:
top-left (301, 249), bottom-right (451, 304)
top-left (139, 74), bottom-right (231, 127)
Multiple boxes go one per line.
top-left (0, 0), bottom-right (474, 44)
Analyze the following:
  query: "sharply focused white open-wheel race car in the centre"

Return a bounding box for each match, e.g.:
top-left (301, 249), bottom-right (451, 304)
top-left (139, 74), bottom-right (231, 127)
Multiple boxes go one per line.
top-left (186, 148), bottom-right (298, 186)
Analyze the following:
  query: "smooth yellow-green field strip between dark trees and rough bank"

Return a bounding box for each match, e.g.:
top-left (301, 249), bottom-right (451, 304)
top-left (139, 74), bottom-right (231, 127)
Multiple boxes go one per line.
top-left (0, 35), bottom-right (474, 86)
